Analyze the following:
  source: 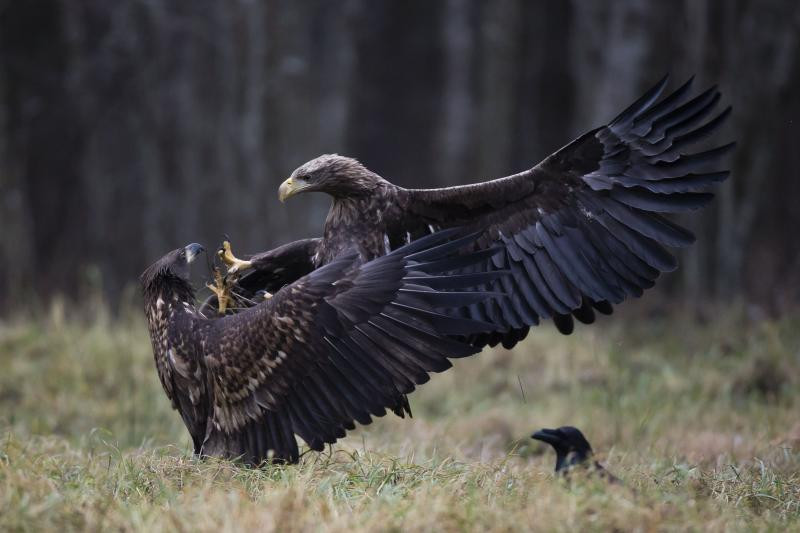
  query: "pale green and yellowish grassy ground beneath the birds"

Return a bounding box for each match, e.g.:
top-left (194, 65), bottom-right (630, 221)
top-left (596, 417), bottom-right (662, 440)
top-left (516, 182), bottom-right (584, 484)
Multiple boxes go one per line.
top-left (0, 307), bottom-right (800, 532)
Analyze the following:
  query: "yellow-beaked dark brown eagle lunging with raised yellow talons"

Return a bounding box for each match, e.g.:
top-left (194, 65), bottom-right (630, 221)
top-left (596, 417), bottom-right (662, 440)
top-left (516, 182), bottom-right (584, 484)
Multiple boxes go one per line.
top-left (222, 77), bottom-right (734, 347)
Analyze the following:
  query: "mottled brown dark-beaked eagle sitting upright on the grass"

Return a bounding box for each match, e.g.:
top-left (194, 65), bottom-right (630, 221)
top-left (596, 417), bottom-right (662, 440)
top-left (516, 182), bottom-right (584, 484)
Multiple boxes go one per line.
top-left (141, 230), bottom-right (507, 464)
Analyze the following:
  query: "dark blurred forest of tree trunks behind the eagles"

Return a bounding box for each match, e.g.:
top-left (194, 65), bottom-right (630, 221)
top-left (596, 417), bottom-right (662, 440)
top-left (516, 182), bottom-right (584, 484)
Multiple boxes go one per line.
top-left (0, 0), bottom-right (800, 311)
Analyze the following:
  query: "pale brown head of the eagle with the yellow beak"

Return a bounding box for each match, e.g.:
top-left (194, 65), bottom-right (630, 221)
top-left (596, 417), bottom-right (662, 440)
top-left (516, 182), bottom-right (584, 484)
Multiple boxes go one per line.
top-left (278, 154), bottom-right (382, 202)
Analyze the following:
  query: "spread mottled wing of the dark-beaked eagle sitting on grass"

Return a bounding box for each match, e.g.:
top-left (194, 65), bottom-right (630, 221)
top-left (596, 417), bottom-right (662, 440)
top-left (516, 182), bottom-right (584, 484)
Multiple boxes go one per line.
top-left (203, 231), bottom-right (504, 463)
